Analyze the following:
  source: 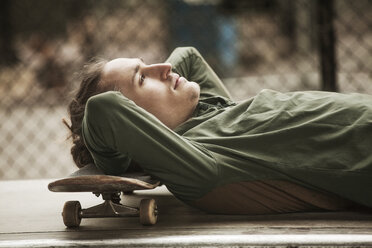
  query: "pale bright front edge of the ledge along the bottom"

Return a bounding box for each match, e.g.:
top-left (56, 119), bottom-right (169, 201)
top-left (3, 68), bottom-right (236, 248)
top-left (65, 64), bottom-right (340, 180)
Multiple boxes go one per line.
top-left (0, 234), bottom-right (372, 248)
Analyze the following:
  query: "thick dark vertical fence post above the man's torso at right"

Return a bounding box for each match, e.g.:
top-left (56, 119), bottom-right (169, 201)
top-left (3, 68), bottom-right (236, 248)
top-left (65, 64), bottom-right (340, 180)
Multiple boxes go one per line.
top-left (317, 0), bottom-right (338, 91)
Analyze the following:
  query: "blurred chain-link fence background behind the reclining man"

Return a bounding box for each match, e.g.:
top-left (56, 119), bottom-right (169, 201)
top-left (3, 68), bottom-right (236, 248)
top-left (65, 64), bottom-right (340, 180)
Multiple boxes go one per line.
top-left (0, 0), bottom-right (372, 180)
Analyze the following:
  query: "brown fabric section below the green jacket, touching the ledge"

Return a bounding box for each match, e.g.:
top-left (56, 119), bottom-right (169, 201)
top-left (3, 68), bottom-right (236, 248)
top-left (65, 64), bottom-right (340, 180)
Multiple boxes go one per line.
top-left (191, 180), bottom-right (356, 214)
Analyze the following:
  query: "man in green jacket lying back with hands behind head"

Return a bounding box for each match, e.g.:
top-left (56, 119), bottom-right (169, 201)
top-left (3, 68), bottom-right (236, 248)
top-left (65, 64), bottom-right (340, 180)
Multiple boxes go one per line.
top-left (70, 47), bottom-right (372, 214)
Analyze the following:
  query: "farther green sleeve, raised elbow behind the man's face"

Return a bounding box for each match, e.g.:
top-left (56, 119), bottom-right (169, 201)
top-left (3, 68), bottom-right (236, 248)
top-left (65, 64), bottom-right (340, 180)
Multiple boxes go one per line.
top-left (166, 47), bottom-right (231, 100)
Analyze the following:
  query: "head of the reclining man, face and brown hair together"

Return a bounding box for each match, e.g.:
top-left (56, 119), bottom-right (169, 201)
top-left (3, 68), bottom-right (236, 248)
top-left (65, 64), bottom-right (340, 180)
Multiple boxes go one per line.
top-left (63, 59), bottom-right (200, 168)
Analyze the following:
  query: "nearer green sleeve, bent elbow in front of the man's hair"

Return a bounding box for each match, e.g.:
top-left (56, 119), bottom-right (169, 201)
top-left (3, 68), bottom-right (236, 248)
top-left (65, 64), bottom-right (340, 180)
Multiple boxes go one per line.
top-left (82, 91), bottom-right (217, 202)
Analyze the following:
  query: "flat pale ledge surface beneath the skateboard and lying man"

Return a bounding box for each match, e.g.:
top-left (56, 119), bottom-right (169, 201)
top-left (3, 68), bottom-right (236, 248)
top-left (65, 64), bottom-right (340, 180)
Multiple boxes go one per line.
top-left (0, 180), bottom-right (372, 247)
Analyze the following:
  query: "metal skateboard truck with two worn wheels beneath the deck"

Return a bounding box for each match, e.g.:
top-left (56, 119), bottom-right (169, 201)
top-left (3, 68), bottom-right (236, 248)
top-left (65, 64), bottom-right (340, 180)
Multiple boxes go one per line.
top-left (62, 192), bottom-right (158, 228)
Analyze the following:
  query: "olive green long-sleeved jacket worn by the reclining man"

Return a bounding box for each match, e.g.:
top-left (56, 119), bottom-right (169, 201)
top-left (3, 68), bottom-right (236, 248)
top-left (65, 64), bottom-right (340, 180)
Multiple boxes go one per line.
top-left (82, 47), bottom-right (372, 207)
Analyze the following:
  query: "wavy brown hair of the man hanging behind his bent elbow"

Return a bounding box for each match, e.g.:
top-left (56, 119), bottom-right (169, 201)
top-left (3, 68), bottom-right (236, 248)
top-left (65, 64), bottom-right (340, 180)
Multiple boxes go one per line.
top-left (62, 59), bottom-right (110, 168)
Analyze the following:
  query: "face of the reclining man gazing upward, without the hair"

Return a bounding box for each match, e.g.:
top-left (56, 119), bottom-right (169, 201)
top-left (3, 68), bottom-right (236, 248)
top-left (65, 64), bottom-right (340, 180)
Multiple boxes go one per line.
top-left (102, 58), bottom-right (200, 129)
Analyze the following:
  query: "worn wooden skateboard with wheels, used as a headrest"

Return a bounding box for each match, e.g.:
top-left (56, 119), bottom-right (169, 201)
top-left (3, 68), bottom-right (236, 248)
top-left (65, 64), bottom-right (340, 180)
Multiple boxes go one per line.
top-left (48, 164), bottom-right (160, 228)
